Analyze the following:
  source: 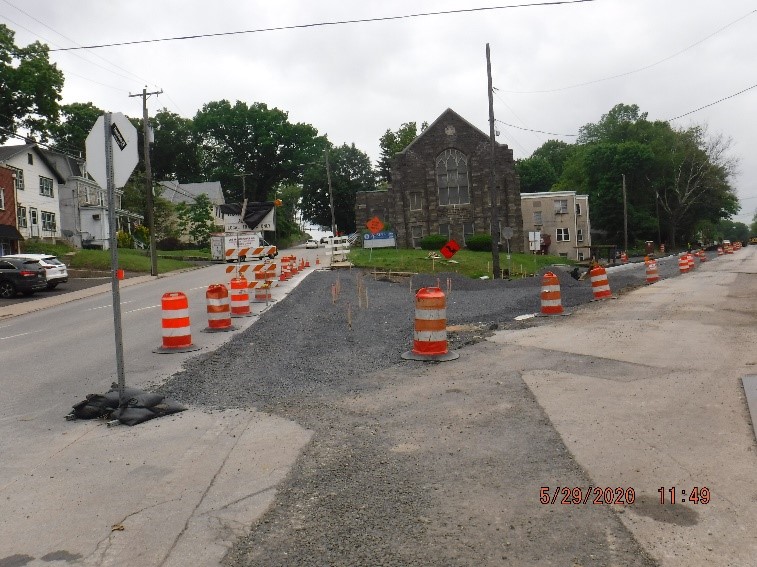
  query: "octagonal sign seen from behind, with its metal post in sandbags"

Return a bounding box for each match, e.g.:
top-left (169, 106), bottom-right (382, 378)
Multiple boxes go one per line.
top-left (86, 112), bottom-right (139, 408)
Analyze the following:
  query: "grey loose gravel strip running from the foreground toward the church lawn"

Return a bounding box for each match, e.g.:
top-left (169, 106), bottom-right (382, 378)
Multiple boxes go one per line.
top-left (159, 258), bottom-right (696, 567)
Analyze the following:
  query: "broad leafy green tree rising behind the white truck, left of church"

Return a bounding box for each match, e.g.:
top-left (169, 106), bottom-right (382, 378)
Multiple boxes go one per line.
top-left (193, 100), bottom-right (326, 202)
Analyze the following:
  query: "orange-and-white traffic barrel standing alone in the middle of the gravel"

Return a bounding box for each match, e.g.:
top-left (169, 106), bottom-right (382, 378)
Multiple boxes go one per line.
top-left (402, 287), bottom-right (460, 361)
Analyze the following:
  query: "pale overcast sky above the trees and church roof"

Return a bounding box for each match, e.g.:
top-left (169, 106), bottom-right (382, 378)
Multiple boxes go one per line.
top-left (0, 0), bottom-right (757, 224)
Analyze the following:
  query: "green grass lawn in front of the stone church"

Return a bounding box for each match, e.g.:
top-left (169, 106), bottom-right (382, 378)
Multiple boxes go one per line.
top-left (349, 248), bottom-right (575, 278)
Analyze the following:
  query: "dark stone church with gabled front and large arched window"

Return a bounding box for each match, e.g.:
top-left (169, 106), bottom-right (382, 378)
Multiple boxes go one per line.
top-left (355, 109), bottom-right (524, 252)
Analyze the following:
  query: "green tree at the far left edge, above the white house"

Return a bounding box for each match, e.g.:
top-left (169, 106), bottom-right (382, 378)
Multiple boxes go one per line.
top-left (0, 24), bottom-right (63, 143)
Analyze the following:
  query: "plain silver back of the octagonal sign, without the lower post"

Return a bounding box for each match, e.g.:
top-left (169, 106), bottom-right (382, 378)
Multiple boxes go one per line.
top-left (85, 112), bottom-right (139, 189)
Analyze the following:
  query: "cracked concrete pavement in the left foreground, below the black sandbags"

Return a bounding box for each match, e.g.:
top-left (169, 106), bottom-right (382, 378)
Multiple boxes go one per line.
top-left (0, 410), bottom-right (310, 567)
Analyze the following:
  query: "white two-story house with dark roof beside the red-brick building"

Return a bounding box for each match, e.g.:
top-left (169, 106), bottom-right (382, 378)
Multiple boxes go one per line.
top-left (0, 143), bottom-right (65, 239)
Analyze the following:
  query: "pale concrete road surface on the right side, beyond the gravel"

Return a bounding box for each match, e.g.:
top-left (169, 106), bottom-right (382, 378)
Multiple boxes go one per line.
top-left (493, 251), bottom-right (757, 567)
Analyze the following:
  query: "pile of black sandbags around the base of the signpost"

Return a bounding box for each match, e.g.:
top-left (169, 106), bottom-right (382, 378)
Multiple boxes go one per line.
top-left (66, 383), bottom-right (187, 425)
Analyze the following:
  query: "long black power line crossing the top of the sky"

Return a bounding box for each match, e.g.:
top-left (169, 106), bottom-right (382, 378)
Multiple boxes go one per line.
top-left (50, 0), bottom-right (597, 51)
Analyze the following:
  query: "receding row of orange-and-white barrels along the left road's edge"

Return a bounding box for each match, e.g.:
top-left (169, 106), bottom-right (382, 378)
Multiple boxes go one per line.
top-left (154, 256), bottom-right (310, 353)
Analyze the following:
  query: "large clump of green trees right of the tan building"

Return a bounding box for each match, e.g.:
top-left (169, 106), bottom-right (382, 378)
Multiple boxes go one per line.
top-left (556, 104), bottom-right (738, 246)
